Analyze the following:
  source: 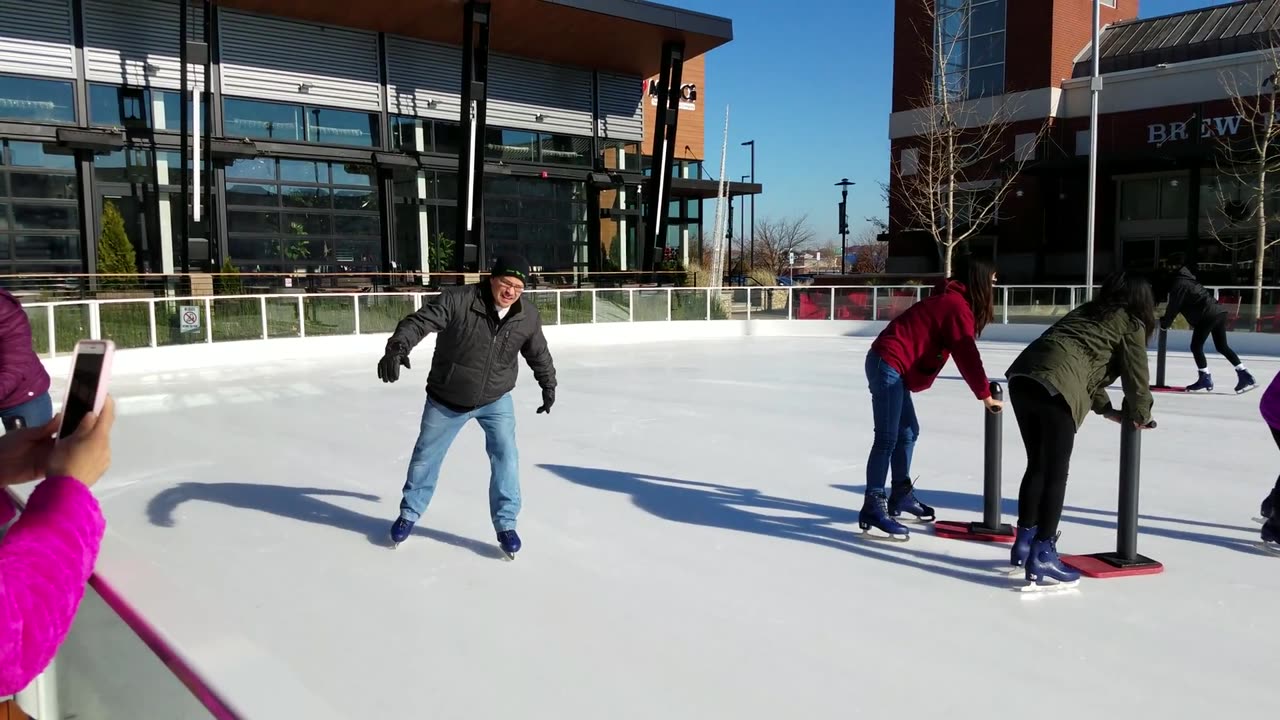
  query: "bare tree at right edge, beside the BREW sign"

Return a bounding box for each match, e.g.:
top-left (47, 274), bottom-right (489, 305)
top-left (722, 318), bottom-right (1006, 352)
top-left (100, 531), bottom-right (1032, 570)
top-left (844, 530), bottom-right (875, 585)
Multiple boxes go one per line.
top-left (1208, 40), bottom-right (1280, 329)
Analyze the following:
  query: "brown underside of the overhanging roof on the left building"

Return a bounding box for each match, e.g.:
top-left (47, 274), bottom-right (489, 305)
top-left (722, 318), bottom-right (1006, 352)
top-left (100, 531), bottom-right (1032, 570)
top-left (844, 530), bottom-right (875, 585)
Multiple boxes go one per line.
top-left (209, 0), bottom-right (733, 77)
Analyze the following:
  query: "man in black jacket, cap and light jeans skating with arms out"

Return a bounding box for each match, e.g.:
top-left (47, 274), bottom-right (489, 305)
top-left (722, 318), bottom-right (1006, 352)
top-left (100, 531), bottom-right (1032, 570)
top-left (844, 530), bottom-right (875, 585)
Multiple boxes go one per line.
top-left (378, 256), bottom-right (556, 559)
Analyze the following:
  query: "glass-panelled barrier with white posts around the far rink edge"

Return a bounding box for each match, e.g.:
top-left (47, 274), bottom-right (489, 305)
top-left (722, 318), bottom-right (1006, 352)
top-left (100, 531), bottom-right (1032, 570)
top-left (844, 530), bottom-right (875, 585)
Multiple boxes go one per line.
top-left (15, 284), bottom-right (1280, 357)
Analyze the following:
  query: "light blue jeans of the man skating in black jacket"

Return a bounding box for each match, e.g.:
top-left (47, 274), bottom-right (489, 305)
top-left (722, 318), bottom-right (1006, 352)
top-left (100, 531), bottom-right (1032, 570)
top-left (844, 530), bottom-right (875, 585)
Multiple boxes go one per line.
top-left (401, 393), bottom-right (520, 532)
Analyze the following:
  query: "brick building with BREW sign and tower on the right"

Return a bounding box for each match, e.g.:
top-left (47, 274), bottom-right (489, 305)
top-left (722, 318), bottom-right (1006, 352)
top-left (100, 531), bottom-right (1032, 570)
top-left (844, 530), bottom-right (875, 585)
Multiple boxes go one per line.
top-left (882, 0), bottom-right (1280, 284)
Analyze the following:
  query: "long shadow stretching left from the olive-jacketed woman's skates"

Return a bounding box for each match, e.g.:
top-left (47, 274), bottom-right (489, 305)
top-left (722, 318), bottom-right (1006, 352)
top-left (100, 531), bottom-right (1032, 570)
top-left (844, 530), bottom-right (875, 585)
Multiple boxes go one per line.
top-left (539, 465), bottom-right (1010, 588)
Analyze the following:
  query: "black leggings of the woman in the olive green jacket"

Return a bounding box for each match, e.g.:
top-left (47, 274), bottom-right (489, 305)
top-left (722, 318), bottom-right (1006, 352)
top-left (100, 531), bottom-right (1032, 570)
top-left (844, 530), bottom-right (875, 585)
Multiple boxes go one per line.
top-left (1009, 378), bottom-right (1075, 539)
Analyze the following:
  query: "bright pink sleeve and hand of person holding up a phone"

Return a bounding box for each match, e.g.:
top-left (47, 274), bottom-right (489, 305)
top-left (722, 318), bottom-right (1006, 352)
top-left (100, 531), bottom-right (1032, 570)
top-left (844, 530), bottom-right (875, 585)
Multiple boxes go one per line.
top-left (0, 398), bottom-right (115, 697)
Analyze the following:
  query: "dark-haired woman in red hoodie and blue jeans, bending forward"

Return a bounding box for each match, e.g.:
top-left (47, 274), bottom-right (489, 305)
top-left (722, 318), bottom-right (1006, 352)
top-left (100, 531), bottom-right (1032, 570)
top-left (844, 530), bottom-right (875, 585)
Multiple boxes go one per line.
top-left (858, 258), bottom-right (1001, 539)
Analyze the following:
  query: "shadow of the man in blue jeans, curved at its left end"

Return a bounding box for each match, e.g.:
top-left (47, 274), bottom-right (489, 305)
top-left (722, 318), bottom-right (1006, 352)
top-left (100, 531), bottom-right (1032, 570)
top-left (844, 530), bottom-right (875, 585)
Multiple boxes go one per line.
top-left (147, 483), bottom-right (502, 559)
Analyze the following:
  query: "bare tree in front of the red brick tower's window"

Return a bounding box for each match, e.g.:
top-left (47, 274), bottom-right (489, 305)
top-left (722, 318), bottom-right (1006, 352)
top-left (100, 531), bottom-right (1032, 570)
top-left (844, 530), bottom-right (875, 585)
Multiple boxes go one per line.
top-left (888, 0), bottom-right (1048, 275)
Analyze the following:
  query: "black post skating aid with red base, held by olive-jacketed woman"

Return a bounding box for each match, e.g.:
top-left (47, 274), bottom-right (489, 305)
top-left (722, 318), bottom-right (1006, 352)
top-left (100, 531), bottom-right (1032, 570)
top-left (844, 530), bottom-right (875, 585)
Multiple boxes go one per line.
top-left (1062, 420), bottom-right (1165, 579)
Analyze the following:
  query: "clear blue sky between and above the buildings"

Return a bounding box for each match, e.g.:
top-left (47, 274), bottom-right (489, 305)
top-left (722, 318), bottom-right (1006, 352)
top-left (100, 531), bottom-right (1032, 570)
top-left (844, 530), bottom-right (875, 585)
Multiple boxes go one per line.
top-left (680, 0), bottom-right (1225, 241)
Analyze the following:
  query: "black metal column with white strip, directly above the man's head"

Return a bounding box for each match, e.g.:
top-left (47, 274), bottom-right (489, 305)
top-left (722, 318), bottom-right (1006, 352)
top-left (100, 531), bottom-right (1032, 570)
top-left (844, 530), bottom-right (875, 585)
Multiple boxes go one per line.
top-left (453, 0), bottom-right (490, 278)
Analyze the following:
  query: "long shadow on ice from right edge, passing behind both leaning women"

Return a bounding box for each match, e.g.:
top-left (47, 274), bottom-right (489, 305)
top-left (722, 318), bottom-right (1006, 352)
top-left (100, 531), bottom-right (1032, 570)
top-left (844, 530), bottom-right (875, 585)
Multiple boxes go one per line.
top-left (832, 484), bottom-right (1266, 555)
